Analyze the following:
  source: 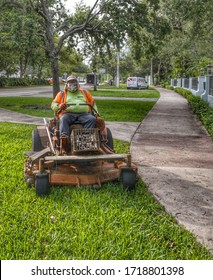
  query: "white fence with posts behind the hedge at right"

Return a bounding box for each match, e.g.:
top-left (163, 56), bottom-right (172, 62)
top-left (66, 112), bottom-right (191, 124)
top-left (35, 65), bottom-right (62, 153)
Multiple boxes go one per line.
top-left (171, 75), bottom-right (213, 107)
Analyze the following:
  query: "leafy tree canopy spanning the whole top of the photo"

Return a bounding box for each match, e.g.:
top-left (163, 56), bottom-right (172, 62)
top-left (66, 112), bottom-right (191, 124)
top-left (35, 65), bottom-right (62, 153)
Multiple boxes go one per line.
top-left (0, 0), bottom-right (213, 91)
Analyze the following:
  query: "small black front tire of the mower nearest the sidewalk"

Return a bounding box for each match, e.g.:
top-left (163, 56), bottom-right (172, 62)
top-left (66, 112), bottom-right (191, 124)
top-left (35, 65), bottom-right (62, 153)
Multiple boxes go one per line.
top-left (120, 167), bottom-right (137, 191)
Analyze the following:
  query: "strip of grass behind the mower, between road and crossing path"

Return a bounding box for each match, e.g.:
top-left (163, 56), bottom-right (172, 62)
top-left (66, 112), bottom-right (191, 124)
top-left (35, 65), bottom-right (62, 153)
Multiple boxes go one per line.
top-left (0, 97), bottom-right (155, 122)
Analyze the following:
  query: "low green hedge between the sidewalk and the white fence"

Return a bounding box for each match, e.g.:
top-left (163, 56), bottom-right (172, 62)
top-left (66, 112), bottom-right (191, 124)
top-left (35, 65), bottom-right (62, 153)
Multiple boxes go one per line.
top-left (174, 88), bottom-right (213, 139)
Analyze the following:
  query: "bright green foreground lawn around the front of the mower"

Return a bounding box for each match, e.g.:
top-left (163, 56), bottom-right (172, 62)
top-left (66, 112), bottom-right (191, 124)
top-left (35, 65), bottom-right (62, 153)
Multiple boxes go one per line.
top-left (0, 123), bottom-right (213, 260)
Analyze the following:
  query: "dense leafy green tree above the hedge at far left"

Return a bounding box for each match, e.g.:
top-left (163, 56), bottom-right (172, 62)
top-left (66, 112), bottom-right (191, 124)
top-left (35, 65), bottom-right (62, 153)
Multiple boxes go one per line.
top-left (0, 1), bottom-right (46, 77)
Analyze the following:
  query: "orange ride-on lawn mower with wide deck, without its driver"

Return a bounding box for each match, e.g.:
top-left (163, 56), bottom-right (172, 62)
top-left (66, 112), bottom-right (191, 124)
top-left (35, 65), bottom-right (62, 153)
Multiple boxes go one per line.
top-left (24, 104), bottom-right (137, 196)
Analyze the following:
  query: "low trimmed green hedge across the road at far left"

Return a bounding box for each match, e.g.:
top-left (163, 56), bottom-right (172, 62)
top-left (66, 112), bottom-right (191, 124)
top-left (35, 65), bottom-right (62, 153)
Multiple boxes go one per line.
top-left (0, 77), bottom-right (49, 87)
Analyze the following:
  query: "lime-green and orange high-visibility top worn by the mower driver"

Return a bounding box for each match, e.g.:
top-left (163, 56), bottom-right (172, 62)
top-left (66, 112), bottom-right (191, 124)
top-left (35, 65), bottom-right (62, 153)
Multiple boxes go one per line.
top-left (51, 89), bottom-right (98, 117)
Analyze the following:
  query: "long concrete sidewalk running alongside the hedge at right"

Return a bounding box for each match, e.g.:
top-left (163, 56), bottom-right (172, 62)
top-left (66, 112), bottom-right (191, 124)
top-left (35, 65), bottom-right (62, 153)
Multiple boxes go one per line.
top-left (131, 88), bottom-right (213, 253)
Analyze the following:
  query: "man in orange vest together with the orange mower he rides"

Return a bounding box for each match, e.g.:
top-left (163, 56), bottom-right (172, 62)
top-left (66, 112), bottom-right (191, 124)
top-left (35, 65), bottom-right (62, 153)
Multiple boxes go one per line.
top-left (24, 76), bottom-right (137, 196)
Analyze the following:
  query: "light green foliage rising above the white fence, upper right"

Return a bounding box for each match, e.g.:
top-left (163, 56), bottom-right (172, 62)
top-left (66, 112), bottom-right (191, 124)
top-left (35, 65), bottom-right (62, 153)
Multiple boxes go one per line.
top-left (151, 0), bottom-right (213, 79)
